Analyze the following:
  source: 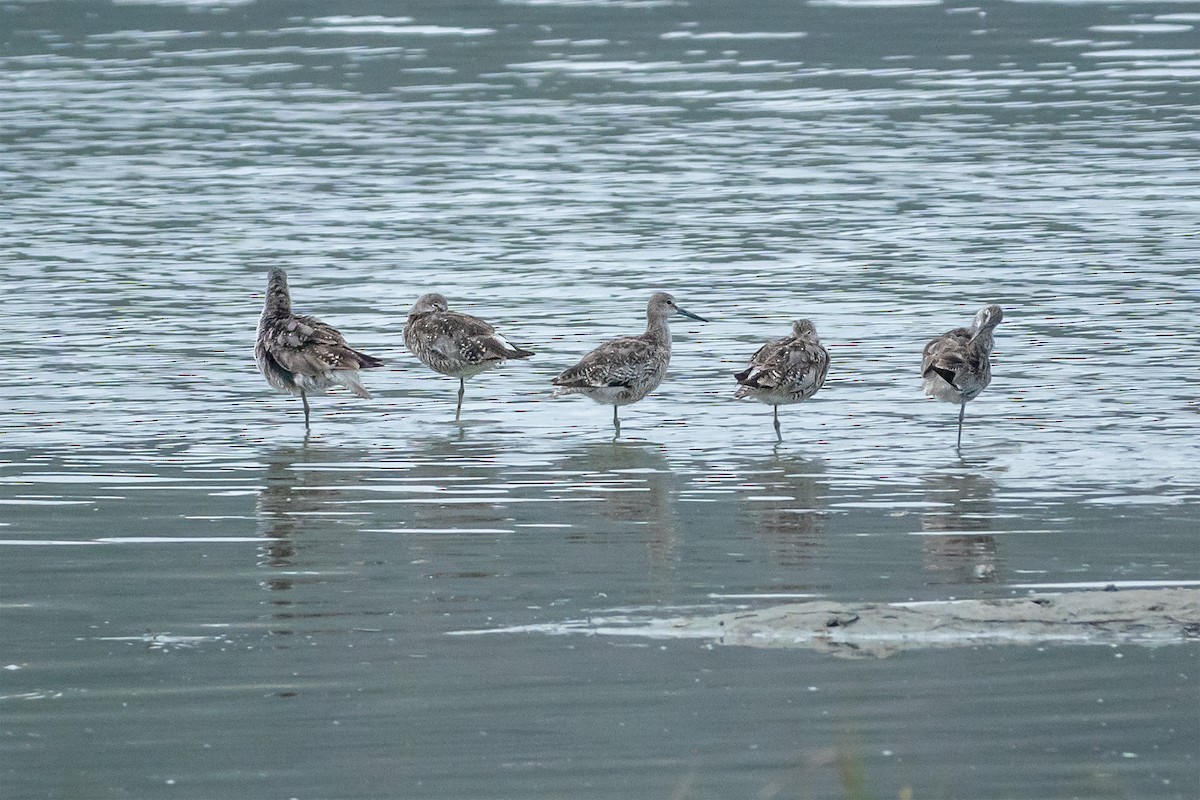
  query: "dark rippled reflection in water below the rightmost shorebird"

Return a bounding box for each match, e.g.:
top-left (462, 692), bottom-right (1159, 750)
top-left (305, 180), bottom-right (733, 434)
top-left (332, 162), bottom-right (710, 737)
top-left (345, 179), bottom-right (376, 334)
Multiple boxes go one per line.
top-left (920, 459), bottom-right (997, 584)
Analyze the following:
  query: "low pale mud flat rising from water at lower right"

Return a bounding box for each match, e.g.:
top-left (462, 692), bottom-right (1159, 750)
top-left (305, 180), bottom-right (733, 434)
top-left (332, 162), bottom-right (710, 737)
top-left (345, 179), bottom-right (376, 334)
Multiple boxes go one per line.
top-left (462, 589), bottom-right (1200, 658)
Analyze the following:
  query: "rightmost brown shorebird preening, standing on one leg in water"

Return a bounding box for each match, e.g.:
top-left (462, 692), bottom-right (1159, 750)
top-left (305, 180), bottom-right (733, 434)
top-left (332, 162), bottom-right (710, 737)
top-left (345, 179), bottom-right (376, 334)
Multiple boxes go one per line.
top-left (920, 306), bottom-right (1004, 447)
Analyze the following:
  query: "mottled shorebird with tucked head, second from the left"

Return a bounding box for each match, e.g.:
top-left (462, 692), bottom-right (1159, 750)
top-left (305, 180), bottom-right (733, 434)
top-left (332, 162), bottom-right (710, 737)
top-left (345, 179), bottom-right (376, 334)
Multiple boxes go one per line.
top-left (404, 293), bottom-right (533, 420)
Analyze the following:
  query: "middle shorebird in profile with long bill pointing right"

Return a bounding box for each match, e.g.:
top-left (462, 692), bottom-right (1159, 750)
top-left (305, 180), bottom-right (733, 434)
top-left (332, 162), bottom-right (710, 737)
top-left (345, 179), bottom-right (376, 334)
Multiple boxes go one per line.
top-left (551, 291), bottom-right (708, 437)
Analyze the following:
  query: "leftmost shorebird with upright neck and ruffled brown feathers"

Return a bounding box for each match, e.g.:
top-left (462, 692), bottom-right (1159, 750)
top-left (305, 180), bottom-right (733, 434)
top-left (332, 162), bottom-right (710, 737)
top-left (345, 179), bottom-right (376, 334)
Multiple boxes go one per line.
top-left (254, 267), bottom-right (384, 431)
